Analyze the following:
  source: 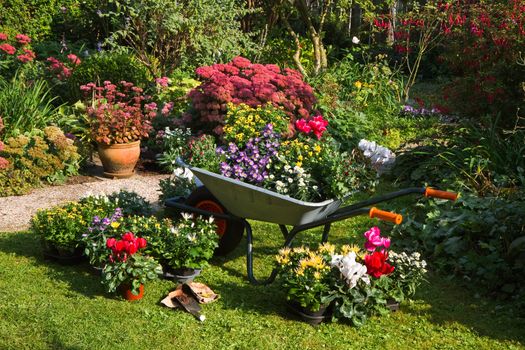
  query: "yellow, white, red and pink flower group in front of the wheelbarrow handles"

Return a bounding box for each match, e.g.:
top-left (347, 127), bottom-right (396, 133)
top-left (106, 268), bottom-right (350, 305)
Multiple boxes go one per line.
top-left (276, 227), bottom-right (426, 327)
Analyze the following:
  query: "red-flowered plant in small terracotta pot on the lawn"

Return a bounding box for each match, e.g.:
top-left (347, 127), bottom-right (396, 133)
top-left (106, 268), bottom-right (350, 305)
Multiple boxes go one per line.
top-left (102, 232), bottom-right (161, 300)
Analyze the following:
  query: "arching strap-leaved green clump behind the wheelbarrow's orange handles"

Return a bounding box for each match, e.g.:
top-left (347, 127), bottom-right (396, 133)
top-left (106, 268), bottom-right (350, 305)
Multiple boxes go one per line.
top-left (394, 124), bottom-right (525, 196)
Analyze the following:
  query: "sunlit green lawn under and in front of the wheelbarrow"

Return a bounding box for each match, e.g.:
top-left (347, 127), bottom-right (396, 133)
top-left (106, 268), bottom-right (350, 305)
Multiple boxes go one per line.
top-left (0, 218), bottom-right (525, 350)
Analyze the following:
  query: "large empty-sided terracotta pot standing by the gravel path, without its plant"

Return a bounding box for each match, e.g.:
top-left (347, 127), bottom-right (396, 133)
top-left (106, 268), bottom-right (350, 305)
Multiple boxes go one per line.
top-left (98, 141), bottom-right (140, 179)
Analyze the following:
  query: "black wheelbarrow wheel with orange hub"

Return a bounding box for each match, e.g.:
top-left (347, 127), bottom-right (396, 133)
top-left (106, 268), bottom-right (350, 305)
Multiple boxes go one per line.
top-left (185, 186), bottom-right (244, 255)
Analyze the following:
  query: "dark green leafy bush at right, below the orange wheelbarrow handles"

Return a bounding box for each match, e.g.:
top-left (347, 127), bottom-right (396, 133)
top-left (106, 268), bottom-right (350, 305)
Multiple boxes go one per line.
top-left (393, 194), bottom-right (525, 298)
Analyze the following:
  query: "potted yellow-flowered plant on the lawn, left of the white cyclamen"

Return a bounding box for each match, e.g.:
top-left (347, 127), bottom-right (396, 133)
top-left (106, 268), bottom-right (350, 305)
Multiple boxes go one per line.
top-left (277, 247), bottom-right (331, 325)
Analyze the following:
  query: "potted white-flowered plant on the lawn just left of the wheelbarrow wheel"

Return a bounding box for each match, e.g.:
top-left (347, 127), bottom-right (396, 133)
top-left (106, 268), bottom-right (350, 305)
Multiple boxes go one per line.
top-left (162, 213), bottom-right (219, 283)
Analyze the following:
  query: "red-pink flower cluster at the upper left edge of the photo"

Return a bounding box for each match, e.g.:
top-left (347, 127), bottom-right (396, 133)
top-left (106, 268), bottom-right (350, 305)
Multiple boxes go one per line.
top-left (0, 32), bottom-right (36, 74)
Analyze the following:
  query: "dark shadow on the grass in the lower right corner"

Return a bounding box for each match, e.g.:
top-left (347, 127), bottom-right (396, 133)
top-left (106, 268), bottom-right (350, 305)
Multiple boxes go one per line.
top-left (403, 275), bottom-right (525, 344)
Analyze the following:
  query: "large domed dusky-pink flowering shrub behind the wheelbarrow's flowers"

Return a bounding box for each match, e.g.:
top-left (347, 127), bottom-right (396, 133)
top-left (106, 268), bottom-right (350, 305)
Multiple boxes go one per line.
top-left (186, 57), bottom-right (316, 135)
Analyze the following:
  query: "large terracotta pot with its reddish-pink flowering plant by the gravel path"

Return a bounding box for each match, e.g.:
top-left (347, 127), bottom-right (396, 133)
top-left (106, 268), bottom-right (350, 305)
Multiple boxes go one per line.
top-left (80, 81), bottom-right (157, 178)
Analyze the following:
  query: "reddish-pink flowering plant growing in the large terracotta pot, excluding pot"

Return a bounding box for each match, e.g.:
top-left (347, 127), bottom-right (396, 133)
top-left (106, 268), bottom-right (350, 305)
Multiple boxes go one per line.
top-left (80, 81), bottom-right (157, 145)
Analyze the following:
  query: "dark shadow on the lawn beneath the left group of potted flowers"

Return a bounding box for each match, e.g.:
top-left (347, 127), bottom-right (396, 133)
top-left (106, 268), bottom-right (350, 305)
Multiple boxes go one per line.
top-left (0, 232), bottom-right (105, 298)
